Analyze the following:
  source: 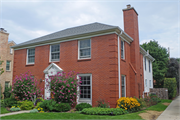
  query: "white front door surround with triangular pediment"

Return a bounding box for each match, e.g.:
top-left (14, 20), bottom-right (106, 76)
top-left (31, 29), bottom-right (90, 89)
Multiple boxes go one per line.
top-left (43, 63), bottom-right (63, 99)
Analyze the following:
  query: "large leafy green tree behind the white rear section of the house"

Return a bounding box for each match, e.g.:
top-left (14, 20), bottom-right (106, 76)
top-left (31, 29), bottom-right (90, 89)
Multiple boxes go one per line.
top-left (141, 40), bottom-right (169, 88)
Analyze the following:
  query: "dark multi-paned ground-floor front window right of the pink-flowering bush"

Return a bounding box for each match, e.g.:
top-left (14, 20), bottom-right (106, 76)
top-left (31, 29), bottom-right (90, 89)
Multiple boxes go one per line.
top-left (79, 74), bottom-right (91, 100)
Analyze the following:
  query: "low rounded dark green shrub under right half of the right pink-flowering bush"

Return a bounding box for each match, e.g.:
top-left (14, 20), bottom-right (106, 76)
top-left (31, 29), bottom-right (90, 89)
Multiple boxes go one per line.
top-left (55, 103), bottom-right (71, 112)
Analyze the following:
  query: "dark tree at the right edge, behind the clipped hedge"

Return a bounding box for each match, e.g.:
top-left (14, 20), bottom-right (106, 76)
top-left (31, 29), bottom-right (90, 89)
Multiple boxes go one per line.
top-left (166, 58), bottom-right (179, 88)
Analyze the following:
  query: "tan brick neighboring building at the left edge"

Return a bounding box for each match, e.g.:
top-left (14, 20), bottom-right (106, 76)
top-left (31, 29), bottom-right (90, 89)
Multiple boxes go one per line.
top-left (0, 28), bottom-right (16, 96)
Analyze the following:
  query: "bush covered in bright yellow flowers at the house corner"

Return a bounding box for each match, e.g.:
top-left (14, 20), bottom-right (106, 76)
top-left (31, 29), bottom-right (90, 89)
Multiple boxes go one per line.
top-left (116, 97), bottom-right (141, 112)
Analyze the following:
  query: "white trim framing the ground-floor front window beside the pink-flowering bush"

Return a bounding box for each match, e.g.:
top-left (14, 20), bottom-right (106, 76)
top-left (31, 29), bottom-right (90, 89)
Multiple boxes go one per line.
top-left (77, 74), bottom-right (92, 105)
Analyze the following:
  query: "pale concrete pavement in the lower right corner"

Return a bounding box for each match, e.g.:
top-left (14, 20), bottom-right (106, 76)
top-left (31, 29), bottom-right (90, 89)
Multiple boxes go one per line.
top-left (157, 96), bottom-right (180, 120)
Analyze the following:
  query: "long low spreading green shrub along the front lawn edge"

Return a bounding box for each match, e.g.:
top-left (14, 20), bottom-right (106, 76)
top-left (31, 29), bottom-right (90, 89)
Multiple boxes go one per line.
top-left (81, 107), bottom-right (127, 115)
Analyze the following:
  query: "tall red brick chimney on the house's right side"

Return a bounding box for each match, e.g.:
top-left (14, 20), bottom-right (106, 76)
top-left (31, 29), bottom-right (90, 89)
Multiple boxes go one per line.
top-left (123, 4), bottom-right (142, 97)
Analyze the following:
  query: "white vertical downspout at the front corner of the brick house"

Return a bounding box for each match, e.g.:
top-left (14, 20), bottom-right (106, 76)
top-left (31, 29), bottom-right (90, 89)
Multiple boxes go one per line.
top-left (118, 31), bottom-right (122, 98)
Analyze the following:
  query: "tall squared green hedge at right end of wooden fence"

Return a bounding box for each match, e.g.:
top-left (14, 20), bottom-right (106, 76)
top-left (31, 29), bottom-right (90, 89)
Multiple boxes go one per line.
top-left (164, 78), bottom-right (177, 99)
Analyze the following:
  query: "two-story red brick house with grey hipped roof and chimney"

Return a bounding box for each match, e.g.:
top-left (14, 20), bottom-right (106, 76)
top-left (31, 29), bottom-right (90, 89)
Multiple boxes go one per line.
top-left (13, 5), bottom-right (154, 107)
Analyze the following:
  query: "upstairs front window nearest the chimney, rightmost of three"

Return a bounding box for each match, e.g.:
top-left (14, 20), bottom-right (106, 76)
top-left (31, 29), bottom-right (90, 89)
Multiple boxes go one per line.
top-left (79, 39), bottom-right (91, 59)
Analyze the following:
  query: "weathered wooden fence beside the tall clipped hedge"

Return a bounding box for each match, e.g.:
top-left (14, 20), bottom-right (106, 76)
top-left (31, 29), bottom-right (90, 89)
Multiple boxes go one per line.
top-left (149, 88), bottom-right (168, 99)
